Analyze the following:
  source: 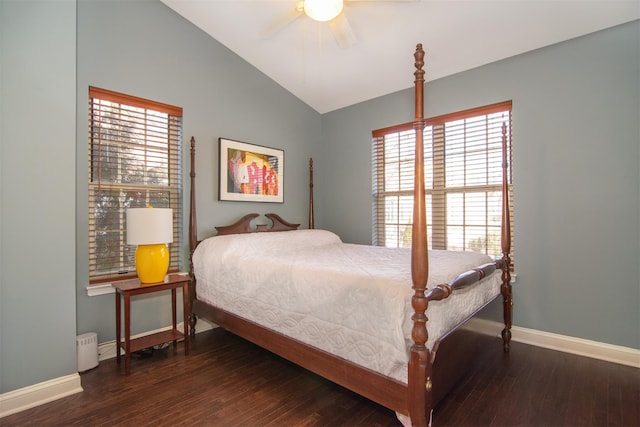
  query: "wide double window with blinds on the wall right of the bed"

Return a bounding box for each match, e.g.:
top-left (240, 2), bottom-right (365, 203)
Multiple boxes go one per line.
top-left (373, 101), bottom-right (514, 257)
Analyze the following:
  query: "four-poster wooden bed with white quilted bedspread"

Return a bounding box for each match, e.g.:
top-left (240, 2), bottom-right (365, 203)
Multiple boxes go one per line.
top-left (189, 44), bottom-right (512, 426)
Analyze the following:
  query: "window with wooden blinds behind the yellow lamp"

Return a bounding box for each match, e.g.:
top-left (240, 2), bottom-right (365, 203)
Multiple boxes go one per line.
top-left (89, 87), bottom-right (182, 283)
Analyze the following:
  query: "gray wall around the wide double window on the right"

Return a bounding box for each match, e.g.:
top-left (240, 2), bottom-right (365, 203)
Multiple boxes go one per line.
top-left (316, 21), bottom-right (640, 348)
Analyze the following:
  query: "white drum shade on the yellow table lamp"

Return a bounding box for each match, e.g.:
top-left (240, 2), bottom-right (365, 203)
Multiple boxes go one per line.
top-left (127, 208), bottom-right (173, 245)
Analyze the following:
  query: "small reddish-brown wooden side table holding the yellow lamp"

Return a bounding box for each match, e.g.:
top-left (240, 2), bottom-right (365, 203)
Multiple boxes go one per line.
top-left (112, 274), bottom-right (191, 375)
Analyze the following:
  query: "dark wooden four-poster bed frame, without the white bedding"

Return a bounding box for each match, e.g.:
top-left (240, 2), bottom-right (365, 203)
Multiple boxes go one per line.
top-left (189, 44), bottom-right (512, 426)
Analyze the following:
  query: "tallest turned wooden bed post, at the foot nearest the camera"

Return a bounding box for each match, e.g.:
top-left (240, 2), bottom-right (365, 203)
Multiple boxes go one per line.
top-left (407, 44), bottom-right (432, 426)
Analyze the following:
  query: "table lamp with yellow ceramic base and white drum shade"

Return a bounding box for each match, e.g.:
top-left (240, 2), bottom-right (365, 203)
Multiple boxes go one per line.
top-left (127, 206), bottom-right (173, 283)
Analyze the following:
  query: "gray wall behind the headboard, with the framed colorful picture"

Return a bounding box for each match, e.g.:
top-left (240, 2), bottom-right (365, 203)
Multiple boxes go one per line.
top-left (76, 0), bottom-right (321, 342)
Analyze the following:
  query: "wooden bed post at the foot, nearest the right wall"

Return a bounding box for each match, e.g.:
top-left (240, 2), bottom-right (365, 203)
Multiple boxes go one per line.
top-left (500, 123), bottom-right (513, 353)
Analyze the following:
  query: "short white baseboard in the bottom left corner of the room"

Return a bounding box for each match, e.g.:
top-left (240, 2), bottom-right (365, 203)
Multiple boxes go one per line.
top-left (0, 373), bottom-right (82, 418)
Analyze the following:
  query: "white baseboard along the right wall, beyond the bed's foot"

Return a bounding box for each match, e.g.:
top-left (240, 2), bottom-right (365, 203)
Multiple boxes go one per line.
top-left (469, 319), bottom-right (640, 368)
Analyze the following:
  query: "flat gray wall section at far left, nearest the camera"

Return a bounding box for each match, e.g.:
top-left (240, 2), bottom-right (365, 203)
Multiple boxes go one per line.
top-left (0, 0), bottom-right (76, 393)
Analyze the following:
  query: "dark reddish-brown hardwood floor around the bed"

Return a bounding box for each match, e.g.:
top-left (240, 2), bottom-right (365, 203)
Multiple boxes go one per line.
top-left (0, 329), bottom-right (640, 427)
